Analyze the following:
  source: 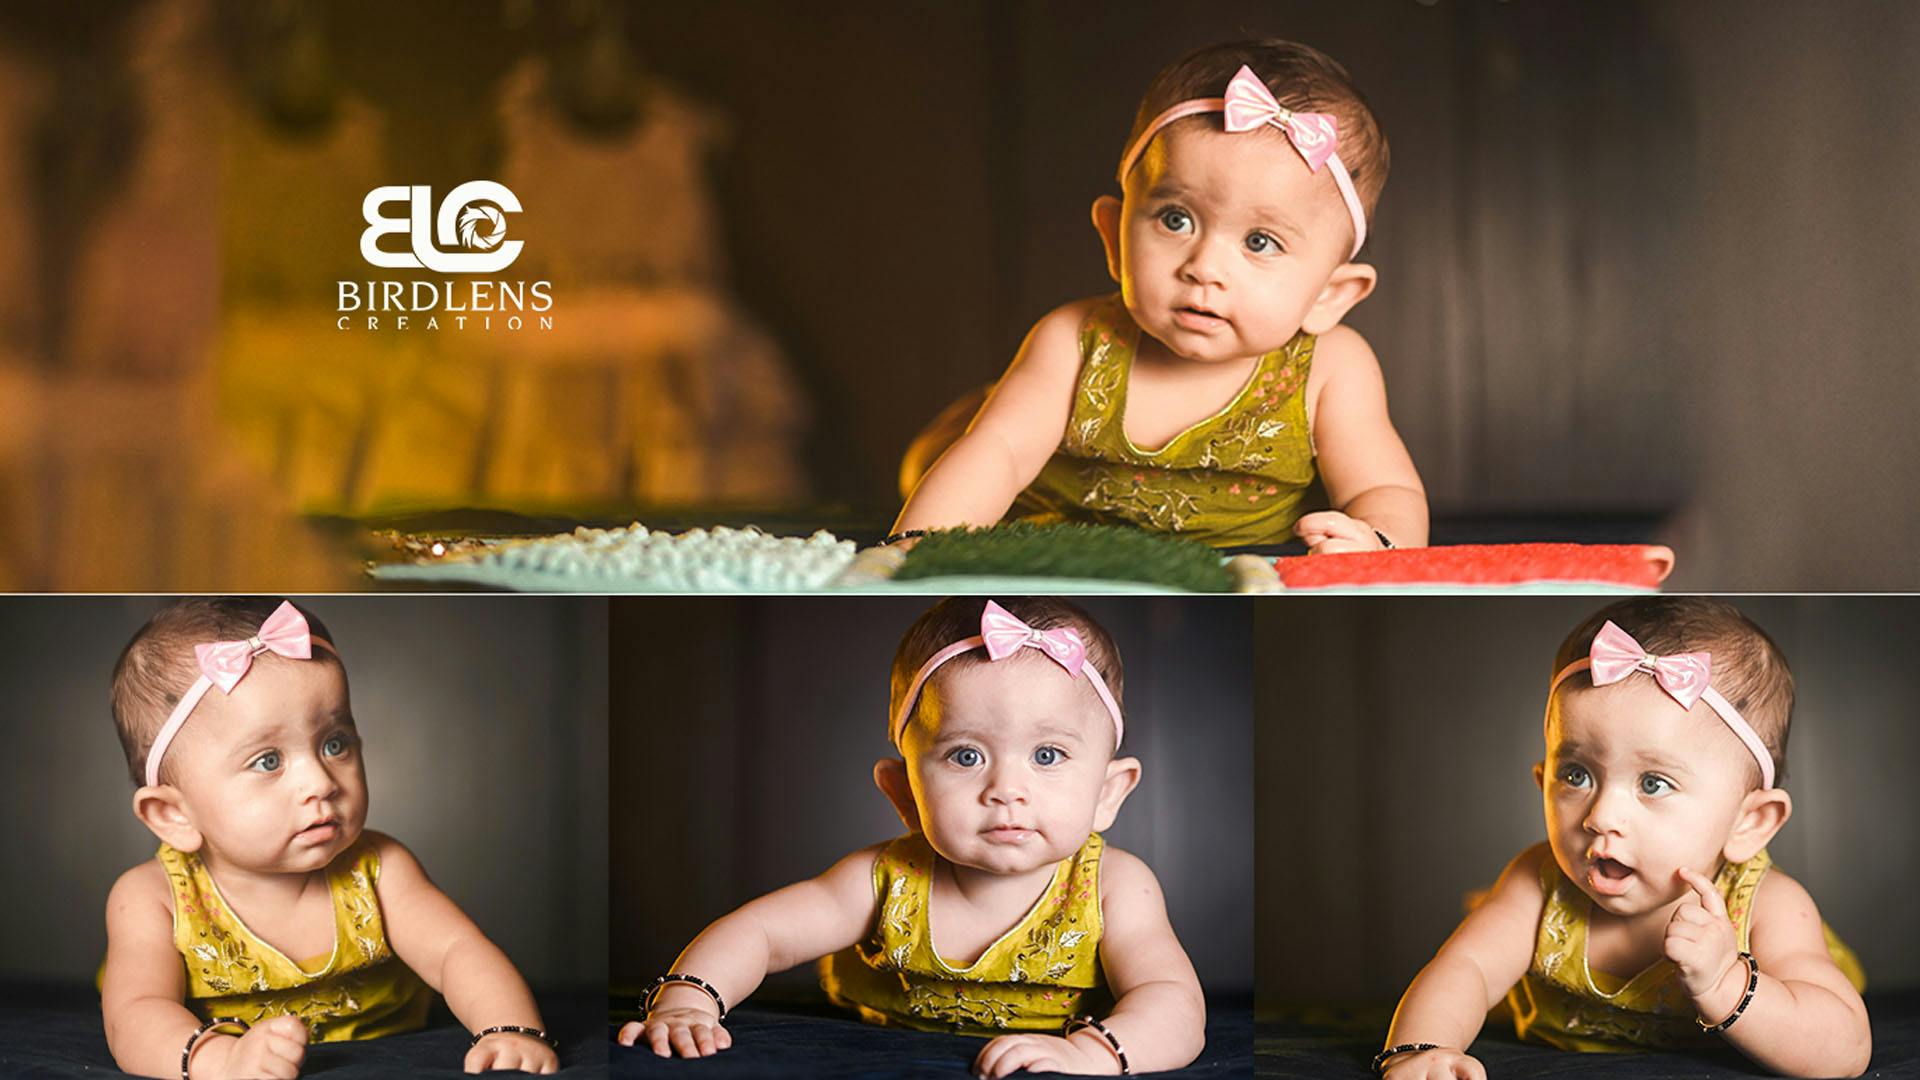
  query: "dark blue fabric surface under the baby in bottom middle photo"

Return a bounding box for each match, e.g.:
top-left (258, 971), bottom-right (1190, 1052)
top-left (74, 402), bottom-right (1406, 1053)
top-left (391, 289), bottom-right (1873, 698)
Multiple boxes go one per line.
top-left (609, 1001), bottom-right (1254, 1080)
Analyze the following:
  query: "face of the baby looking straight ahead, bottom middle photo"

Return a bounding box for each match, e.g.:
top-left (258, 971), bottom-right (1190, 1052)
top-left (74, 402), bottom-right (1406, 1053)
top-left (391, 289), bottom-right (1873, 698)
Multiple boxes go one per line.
top-left (904, 650), bottom-right (1114, 874)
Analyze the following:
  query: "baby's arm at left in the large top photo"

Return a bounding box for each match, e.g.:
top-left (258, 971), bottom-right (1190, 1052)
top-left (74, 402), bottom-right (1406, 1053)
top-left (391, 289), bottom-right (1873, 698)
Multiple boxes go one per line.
top-left (893, 300), bottom-right (1094, 532)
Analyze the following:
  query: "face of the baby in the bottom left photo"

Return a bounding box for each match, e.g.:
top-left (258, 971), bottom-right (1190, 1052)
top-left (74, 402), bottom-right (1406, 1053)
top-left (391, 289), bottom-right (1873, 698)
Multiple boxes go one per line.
top-left (175, 655), bottom-right (367, 872)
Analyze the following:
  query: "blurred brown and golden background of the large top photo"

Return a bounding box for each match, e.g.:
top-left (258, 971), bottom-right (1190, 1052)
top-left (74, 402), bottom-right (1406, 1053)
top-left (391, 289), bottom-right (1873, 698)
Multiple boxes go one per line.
top-left (0, 0), bottom-right (1920, 590)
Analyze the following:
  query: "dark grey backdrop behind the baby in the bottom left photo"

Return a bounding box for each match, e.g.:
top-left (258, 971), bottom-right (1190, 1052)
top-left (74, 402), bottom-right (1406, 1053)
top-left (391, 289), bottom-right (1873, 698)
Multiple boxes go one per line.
top-left (0, 596), bottom-right (607, 991)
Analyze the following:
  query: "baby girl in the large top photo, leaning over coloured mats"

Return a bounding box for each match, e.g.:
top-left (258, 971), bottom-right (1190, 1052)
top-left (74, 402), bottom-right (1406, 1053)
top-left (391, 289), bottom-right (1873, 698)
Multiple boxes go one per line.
top-left (889, 40), bottom-right (1427, 552)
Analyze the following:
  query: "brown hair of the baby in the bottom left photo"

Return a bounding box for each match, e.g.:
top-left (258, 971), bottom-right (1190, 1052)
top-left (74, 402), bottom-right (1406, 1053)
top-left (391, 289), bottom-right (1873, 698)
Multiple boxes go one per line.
top-left (113, 596), bottom-right (340, 786)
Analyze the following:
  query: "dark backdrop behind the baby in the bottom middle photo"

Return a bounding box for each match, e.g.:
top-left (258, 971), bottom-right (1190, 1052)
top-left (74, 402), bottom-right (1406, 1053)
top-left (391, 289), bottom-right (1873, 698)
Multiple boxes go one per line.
top-left (609, 598), bottom-right (1254, 994)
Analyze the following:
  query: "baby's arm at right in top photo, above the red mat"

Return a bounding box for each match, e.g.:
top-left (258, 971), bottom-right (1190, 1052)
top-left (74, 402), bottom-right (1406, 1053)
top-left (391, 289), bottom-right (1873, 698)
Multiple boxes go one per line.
top-left (1294, 327), bottom-right (1427, 553)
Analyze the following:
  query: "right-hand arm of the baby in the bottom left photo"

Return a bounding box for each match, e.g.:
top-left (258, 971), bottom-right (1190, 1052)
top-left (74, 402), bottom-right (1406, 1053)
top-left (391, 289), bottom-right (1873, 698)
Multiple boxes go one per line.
top-left (367, 832), bottom-right (561, 1072)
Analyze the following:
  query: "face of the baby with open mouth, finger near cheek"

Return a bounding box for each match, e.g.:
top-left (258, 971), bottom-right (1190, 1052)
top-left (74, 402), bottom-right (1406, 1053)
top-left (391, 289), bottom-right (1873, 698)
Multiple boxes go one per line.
top-left (1542, 675), bottom-right (1749, 915)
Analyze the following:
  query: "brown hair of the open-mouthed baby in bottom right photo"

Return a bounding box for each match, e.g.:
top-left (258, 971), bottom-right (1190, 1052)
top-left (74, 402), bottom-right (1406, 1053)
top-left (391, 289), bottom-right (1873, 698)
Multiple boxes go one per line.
top-left (1553, 596), bottom-right (1793, 788)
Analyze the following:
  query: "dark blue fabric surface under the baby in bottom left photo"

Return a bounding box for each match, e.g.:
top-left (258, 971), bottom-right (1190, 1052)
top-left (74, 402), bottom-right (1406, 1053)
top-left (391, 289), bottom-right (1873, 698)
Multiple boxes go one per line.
top-left (0, 988), bottom-right (607, 1080)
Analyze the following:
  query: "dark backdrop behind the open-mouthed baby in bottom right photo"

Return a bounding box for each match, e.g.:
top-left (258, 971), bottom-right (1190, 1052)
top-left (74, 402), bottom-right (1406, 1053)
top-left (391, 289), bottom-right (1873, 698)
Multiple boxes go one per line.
top-left (1256, 596), bottom-right (1920, 1005)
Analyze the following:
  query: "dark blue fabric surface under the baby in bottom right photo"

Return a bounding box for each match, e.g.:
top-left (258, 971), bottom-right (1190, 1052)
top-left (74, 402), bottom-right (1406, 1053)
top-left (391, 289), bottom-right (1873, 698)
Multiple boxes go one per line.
top-left (1254, 992), bottom-right (1920, 1080)
